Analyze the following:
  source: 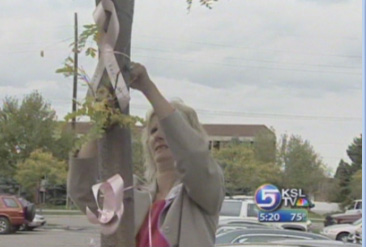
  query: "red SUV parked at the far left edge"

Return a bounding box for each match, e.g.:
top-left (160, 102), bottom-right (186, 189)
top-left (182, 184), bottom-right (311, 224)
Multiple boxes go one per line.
top-left (0, 195), bottom-right (26, 234)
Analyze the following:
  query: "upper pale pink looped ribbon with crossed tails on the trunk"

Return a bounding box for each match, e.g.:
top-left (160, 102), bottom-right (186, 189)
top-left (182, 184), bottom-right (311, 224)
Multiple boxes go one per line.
top-left (88, 0), bottom-right (130, 110)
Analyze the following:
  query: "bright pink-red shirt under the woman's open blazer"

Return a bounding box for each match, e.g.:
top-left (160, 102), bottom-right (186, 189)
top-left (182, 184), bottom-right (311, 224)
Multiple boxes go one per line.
top-left (136, 200), bottom-right (169, 247)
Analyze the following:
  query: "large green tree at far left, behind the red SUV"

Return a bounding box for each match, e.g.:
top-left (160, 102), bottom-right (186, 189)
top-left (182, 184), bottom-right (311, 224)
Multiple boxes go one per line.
top-left (0, 92), bottom-right (72, 176)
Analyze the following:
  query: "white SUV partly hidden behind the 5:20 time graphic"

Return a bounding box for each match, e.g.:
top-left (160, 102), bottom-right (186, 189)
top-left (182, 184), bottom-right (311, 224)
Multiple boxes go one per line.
top-left (219, 199), bottom-right (311, 231)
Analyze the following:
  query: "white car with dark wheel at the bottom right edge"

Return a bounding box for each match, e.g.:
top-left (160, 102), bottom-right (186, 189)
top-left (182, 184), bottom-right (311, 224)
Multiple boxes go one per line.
top-left (321, 218), bottom-right (362, 242)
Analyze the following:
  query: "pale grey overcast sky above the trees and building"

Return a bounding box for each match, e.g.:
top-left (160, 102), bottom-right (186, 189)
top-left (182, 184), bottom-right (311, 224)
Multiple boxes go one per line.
top-left (0, 0), bottom-right (362, 175)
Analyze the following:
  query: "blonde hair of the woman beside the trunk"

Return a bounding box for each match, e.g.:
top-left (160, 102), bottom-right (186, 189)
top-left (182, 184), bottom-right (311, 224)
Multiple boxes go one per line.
top-left (141, 100), bottom-right (208, 184)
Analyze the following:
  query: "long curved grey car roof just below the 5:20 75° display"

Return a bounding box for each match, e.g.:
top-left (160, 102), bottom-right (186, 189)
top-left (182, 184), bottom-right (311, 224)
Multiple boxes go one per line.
top-left (216, 228), bottom-right (329, 244)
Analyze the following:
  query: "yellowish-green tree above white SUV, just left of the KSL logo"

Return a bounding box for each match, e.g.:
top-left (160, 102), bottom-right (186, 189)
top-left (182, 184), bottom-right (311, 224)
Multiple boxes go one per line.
top-left (214, 144), bottom-right (281, 194)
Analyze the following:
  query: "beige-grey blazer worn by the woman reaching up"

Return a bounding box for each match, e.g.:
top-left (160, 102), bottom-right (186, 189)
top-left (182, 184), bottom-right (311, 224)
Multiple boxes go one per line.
top-left (68, 110), bottom-right (225, 247)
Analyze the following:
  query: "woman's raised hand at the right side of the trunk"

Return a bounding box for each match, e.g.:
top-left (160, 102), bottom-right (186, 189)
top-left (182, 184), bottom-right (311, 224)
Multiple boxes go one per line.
top-left (130, 62), bottom-right (154, 95)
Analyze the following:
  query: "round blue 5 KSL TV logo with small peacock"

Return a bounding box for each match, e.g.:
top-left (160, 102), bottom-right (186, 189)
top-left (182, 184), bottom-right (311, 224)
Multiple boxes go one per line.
top-left (254, 184), bottom-right (311, 211)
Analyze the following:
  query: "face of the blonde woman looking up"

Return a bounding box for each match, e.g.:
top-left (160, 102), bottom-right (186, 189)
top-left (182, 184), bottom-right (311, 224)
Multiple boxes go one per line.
top-left (148, 116), bottom-right (174, 165)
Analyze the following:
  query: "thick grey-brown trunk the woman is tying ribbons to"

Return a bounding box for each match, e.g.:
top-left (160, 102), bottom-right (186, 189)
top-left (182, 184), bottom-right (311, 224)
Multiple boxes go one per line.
top-left (96, 0), bottom-right (135, 247)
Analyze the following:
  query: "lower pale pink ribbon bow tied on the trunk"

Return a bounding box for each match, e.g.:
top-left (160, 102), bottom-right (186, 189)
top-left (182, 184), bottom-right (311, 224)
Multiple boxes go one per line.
top-left (86, 174), bottom-right (124, 235)
